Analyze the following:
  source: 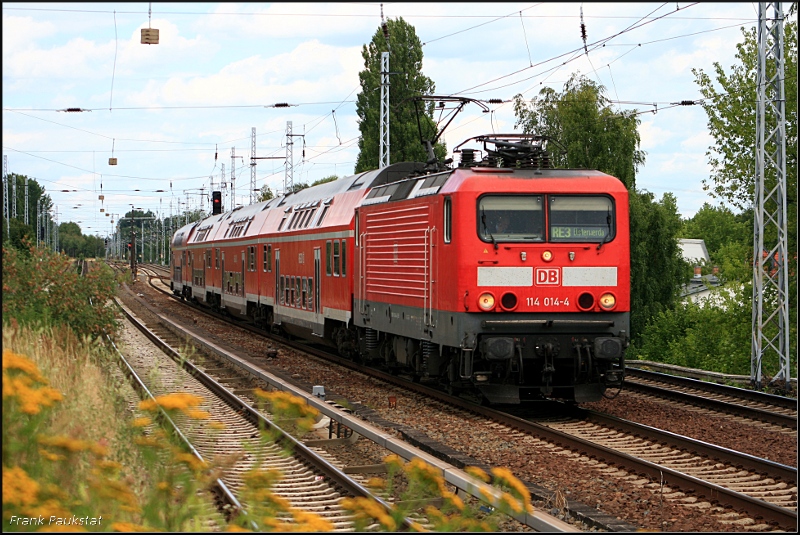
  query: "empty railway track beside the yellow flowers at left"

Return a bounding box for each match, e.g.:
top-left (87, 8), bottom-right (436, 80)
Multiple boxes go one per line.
top-left (111, 296), bottom-right (400, 531)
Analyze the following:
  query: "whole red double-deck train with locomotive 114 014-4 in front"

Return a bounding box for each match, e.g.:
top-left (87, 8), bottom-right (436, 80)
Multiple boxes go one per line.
top-left (173, 135), bottom-right (630, 403)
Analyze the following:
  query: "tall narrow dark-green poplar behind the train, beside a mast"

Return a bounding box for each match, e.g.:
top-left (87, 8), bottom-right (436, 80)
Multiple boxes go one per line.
top-left (355, 17), bottom-right (447, 173)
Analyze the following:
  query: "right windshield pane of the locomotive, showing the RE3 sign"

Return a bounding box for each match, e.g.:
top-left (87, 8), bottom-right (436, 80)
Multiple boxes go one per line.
top-left (548, 195), bottom-right (615, 243)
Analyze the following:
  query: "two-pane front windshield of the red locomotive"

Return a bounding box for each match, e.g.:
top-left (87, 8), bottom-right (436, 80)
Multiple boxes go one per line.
top-left (478, 195), bottom-right (615, 244)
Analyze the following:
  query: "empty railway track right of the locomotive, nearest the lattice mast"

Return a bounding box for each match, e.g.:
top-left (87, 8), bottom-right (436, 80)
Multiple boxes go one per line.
top-left (623, 367), bottom-right (797, 434)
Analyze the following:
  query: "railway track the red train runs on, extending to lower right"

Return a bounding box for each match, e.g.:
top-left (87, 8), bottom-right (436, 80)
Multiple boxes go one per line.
top-left (130, 264), bottom-right (797, 529)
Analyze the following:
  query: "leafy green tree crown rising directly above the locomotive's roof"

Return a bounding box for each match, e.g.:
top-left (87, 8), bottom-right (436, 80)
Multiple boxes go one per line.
top-left (514, 74), bottom-right (645, 191)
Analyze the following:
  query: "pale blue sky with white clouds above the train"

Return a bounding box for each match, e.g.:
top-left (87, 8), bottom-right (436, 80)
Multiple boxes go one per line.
top-left (2, 2), bottom-right (758, 236)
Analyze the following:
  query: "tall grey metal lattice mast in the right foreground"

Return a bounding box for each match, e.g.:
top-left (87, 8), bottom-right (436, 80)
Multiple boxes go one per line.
top-left (750, 2), bottom-right (791, 387)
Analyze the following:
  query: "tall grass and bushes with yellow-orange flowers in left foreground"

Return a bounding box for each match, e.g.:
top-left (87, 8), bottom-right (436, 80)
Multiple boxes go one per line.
top-left (2, 248), bottom-right (532, 532)
